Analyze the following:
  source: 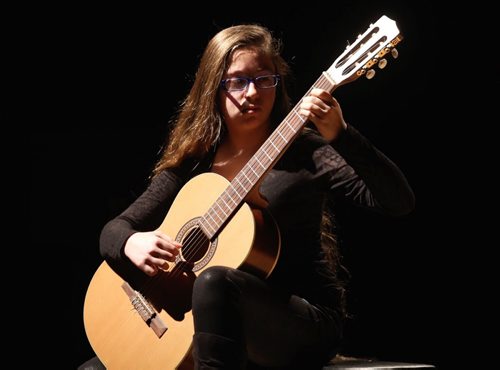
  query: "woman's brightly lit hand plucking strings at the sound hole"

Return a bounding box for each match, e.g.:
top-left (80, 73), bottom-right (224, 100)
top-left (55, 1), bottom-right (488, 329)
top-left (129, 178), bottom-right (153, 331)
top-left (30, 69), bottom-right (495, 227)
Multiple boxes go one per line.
top-left (123, 230), bottom-right (182, 276)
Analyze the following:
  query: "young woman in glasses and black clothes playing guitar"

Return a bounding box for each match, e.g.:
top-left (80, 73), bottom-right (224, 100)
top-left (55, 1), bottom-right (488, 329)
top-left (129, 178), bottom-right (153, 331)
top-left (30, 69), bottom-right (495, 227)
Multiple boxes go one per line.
top-left (100, 25), bottom-right (414, 369)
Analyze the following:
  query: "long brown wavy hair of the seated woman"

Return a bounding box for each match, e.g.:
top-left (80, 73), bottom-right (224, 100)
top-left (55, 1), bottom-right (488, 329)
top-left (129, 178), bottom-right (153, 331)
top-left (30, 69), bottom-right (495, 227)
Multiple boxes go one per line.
top-left (153, 24), bottom-right (291, 175)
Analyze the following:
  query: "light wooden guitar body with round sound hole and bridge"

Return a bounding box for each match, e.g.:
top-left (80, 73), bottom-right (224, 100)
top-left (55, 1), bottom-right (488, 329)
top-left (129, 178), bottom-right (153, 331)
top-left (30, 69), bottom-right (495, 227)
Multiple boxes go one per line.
top-left (84, 173), bottom-right (280, 370)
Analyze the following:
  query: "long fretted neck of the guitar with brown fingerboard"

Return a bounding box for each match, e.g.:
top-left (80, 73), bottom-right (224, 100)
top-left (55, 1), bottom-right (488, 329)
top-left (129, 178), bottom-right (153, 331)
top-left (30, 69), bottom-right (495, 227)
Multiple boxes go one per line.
top-left (200, 73), bottom-right (337, 239)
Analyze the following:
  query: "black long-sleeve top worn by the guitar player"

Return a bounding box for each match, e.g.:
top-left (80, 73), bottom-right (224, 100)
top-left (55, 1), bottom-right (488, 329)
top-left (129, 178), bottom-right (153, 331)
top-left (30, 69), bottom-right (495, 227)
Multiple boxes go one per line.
top-left (100, 125), bottom-right (414, 308)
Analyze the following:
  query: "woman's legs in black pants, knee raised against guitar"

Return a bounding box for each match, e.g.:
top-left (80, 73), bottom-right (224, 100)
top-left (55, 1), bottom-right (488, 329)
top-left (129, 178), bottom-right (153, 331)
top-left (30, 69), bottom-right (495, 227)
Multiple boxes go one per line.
top-left (193, 267), bottom-right (341, 369)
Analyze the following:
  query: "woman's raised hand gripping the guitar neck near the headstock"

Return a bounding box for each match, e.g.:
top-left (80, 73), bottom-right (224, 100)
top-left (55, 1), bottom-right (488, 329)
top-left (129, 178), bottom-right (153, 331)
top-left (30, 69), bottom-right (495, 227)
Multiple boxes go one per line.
top-left (299, 88), bottom-right (347, 142)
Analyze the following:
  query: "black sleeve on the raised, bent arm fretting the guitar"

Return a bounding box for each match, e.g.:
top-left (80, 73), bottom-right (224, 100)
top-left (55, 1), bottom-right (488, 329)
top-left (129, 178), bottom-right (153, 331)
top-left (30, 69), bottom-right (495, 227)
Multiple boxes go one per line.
top-left (316, 125), bottom-right (415, 216)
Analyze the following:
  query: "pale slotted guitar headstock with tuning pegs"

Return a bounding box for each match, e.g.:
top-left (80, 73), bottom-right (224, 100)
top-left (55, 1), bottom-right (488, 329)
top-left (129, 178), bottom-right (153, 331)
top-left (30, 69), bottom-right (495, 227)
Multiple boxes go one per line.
top-left (326, 15), bottom-right (403, 86)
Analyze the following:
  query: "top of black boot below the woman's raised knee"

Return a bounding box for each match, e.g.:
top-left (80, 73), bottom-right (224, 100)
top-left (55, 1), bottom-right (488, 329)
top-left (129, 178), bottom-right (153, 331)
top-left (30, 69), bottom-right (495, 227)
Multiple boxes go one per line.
top-left (193, 333), bottom-right (246, 370)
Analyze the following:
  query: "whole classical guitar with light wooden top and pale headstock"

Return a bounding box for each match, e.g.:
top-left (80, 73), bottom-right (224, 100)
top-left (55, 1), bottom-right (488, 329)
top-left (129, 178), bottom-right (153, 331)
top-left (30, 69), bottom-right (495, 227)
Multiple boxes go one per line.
top-left (83, 16), bottom-right (402, 370)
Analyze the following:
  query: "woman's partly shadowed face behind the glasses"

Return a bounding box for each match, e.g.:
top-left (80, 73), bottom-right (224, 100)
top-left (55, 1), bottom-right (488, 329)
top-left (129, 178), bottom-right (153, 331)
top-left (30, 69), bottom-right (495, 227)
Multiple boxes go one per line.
top-left (219, 48), bottom-right (276, 134)
